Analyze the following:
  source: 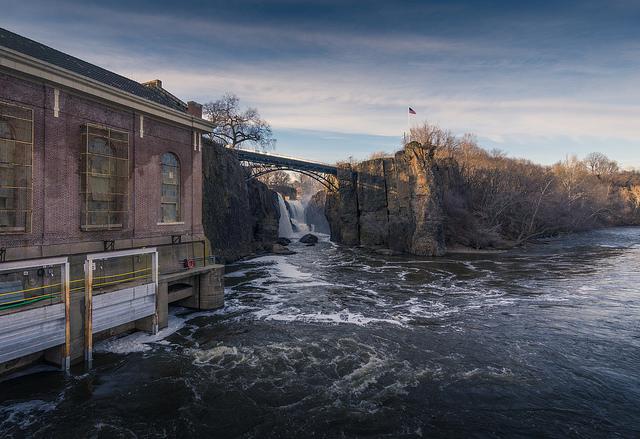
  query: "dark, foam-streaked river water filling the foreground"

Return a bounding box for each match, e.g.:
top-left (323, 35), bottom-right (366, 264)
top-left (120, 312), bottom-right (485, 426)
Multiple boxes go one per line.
top-left (0, 228), bottom-right (640, 438)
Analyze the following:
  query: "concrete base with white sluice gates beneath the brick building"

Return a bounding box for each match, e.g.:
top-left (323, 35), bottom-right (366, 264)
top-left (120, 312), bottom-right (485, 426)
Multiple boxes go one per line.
top-left (0, 242), bottom-right (224, 374)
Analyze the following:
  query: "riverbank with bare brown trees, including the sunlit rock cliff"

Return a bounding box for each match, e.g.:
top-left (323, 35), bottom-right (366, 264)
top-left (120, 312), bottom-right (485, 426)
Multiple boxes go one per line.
top-left (326, 125), bottom-right (640, 255)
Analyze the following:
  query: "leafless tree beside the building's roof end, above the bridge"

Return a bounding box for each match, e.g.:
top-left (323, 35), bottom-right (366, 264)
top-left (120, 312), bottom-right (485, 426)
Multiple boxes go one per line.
top-left (203, 94), bottom-right (276, 150)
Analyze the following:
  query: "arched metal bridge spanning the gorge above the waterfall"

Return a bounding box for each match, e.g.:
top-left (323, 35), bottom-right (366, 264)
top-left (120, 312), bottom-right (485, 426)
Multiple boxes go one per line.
top-left (235, 149), bottom-right (338, 192)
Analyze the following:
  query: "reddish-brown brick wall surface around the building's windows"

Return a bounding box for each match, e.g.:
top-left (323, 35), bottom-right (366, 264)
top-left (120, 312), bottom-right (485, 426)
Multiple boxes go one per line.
top-left (0, 72), bottom-right (203, 260)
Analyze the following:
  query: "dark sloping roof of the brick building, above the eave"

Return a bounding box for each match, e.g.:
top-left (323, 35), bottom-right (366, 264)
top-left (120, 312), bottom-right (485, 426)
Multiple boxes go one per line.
top-left (0, 28), bottom-right (187, 112)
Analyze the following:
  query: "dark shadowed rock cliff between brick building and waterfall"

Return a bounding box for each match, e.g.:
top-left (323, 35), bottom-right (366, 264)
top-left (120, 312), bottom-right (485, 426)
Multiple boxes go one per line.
top-left (202, 144), bottom-right (280, 262)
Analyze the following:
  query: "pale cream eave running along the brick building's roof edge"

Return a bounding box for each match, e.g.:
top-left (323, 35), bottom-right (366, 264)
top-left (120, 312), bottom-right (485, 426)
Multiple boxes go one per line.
top-left (0, 46), bottom-right (213, 132)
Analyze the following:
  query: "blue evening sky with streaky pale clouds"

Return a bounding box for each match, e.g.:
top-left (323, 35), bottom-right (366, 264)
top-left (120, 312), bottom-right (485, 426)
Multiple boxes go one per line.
top-left (0, 0), bottom-right (640, 168)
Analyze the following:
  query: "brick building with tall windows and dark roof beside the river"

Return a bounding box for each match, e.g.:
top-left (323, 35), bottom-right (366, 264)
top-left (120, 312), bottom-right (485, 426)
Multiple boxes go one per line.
top-left (0, 29), bottom-right (221, 372)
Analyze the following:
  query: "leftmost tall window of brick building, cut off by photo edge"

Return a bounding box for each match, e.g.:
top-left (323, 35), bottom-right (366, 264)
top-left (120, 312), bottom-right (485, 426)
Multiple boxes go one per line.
top-left (0, 102), bottom-right (33, 233)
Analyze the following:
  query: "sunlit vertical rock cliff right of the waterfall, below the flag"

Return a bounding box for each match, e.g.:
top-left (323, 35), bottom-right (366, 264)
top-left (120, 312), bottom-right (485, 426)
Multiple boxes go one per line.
top-left (325, 142), bottom-right (445, 256)
